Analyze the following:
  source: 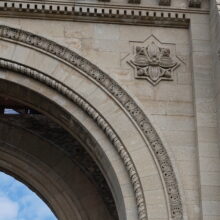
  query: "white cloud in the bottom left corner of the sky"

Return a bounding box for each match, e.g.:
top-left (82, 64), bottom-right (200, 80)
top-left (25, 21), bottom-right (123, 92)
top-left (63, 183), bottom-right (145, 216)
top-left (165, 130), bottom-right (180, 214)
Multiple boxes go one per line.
top-left (0, 197), bottom-right (19, 220)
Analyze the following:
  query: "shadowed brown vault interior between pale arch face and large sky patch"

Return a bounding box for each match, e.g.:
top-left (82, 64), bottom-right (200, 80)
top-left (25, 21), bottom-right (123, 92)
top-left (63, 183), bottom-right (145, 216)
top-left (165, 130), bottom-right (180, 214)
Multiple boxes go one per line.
top-left (0, 80), bottom-right (125, 220)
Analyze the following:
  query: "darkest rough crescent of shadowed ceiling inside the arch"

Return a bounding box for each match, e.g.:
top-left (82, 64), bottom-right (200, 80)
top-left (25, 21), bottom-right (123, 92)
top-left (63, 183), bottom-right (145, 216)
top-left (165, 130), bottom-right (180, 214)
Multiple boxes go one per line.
top-left (0, 114), bottom-right (118, 220)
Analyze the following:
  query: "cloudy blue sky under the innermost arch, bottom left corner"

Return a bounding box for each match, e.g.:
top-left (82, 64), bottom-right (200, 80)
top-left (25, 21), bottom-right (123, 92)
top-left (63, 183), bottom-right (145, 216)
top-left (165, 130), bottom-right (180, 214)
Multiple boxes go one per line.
top-left (0, 172), bottom-right (57, 220)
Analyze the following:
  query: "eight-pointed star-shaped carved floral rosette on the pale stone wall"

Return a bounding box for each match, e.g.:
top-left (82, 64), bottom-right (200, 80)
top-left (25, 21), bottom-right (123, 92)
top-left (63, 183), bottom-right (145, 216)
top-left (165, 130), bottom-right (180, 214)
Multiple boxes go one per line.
top-left (128, 37), bottom-right (180, 85)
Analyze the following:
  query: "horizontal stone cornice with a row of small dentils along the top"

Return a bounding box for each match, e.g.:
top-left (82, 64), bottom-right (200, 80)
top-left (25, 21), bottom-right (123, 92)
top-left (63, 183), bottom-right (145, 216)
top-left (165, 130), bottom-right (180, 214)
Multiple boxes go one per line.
top-left (0, 1), bottom-right (207, 28)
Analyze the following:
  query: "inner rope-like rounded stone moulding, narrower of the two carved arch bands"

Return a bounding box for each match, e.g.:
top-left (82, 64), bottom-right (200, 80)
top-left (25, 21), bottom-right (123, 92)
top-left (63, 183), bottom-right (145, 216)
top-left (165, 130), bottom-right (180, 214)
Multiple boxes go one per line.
top-left (0, 58), bottom-right (147, 220)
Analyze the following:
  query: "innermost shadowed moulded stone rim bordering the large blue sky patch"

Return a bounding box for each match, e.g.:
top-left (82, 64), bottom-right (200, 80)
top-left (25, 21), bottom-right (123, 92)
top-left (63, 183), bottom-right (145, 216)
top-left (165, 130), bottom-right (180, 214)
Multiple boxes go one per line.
top-left (0, 140), bottom-right (81, 220)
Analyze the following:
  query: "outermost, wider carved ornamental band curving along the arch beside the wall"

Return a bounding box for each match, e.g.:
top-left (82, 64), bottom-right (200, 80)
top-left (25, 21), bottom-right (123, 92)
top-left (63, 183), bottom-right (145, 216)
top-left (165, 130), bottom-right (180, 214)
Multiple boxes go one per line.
top-left (0, 25), bottom-right (183, 219)
